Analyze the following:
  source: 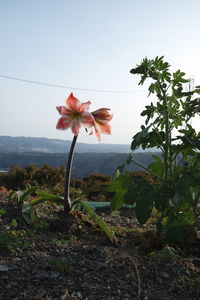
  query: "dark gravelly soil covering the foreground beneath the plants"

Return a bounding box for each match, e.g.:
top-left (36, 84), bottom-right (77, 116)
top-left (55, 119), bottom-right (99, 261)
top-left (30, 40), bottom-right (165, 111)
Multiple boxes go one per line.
top-left (0, 194), bottom-right (200, 300)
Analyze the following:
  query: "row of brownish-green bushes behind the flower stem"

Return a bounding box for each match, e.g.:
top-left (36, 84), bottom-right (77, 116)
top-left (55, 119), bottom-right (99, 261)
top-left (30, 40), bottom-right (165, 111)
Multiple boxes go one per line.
top-left (0, 168), bottom-right (116, 201)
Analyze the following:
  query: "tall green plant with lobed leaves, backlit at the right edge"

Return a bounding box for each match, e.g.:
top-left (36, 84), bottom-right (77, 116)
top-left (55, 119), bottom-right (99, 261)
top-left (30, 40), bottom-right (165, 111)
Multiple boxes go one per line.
top-left (110, 57), bottom-right (200, 242)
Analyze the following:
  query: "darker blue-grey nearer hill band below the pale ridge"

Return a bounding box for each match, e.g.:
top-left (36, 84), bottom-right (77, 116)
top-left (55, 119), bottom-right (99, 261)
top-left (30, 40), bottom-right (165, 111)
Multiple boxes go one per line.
top-left (0, 152), bottom-right (159, 178)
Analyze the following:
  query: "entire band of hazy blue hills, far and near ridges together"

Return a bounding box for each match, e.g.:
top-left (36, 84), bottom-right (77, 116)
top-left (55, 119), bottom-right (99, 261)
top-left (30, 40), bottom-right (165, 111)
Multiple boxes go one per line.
top-left (0, 136), bottom-right (160, 178)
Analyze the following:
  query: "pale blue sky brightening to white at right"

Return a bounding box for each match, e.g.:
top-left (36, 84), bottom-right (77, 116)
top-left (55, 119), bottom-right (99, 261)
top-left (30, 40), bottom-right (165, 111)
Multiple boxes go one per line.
top-left (0, 0), bottom-right (200, 144)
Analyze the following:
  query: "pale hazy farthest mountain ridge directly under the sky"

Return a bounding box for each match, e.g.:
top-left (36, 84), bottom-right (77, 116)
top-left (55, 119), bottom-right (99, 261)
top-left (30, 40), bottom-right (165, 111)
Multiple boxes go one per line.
top-left (0, 136), bottom-right (131, 153)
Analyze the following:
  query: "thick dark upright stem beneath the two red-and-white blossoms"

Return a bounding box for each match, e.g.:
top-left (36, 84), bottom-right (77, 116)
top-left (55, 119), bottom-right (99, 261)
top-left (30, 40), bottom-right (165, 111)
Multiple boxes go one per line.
top-left (64, 136), bottom-right (78, 213)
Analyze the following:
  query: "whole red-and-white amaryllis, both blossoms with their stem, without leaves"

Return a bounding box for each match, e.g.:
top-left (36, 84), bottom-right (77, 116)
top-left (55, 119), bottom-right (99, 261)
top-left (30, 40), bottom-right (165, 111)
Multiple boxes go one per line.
top-left (56, 93), bottom-right (112, 212)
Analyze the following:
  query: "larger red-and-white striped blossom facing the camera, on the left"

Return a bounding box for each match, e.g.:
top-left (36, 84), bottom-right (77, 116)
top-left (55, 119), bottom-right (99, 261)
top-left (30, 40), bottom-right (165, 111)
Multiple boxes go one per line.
top-left (56, 93), bottom-right (94, 136)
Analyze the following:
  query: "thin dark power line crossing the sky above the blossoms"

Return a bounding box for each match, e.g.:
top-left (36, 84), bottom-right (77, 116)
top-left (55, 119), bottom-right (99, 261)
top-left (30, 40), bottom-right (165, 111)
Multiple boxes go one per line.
top-left (0, 75), bottom-right (143, 93)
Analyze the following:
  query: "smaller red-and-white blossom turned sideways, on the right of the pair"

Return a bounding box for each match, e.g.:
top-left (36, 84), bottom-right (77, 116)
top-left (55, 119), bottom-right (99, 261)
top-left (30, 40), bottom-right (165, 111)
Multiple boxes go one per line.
top-left (90, 108), bottom-right (113, 141)
